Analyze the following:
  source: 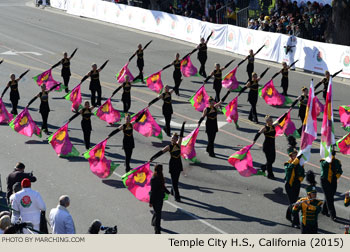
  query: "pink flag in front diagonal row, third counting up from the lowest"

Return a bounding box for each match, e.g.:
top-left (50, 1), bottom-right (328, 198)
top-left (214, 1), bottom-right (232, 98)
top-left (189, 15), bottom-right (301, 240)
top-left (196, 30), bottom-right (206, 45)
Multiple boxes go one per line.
top-left (48, 123), bottom-right (79, 157)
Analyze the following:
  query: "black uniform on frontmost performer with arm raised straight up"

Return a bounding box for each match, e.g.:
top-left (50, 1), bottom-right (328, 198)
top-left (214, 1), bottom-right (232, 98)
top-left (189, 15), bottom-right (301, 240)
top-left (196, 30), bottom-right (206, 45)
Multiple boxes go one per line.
top-left (169, 144), bottom-right (183, 200)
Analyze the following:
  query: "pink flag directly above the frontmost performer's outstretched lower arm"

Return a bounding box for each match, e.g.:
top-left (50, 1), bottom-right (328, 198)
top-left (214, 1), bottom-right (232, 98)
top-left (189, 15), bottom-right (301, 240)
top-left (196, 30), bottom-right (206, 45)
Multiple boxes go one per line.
top-left (131, 108), bottom-right (163, 140)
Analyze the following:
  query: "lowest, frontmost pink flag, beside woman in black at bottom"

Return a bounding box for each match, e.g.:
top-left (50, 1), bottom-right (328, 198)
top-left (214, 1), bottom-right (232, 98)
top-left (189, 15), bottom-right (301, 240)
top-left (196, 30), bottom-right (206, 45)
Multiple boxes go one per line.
top-left (121, 162), bottom-right (153, 203)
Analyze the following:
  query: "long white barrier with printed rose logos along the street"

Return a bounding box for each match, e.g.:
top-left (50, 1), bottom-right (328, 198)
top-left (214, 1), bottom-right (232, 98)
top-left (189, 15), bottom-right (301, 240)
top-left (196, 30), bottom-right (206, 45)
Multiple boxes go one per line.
top-left (51, 0), bottom-right (350, 78)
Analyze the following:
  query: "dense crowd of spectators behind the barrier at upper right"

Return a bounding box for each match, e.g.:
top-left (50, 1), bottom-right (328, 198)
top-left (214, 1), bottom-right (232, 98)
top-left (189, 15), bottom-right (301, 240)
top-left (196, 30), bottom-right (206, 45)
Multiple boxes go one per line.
top-left (248, 0), bottom-right (332, 42)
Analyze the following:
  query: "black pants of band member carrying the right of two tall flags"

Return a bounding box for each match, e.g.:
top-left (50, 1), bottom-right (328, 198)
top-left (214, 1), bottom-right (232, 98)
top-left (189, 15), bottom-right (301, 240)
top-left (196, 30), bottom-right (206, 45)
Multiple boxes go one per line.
top-left (321, 178), bottom-right (337, 218)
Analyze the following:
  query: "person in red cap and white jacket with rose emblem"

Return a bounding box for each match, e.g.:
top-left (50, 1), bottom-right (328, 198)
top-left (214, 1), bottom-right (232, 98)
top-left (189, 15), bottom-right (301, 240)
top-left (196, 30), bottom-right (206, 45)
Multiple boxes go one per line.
top-left (11, 178), bottom-right (46, 233)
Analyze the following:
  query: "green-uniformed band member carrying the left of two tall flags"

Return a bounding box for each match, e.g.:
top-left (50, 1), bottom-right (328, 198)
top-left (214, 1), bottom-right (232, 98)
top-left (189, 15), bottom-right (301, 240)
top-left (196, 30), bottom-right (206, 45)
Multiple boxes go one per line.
top-left (284, 148), bottom-right (305, 227)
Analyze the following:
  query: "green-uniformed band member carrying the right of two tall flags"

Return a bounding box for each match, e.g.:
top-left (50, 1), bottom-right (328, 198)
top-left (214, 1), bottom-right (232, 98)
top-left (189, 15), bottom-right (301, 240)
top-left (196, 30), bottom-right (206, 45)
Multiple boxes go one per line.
top-left (320, 150), bottom-right (343, 221)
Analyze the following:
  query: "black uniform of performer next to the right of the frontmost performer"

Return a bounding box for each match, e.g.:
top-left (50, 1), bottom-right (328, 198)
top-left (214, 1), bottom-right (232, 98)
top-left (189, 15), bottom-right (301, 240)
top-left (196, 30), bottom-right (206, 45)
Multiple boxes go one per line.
top-left (205, 107), bottom-right (218, 155)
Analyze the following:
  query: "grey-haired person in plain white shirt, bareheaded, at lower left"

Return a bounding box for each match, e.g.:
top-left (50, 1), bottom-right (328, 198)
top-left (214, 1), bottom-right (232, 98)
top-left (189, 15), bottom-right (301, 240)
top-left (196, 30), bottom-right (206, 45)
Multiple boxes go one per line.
top-left (50, 195), bottom-right (75, 234)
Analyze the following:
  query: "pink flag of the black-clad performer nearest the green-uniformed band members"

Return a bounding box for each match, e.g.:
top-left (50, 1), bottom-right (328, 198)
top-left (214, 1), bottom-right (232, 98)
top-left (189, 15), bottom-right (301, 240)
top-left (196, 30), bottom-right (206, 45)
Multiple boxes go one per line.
top-left (228, 144), bottom-right (258, 177)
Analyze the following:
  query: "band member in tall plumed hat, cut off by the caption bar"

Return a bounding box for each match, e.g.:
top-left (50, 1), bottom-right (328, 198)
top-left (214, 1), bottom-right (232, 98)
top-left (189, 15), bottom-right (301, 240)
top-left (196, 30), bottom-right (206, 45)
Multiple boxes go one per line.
top-left (292, 170), bottom-right (323, 234)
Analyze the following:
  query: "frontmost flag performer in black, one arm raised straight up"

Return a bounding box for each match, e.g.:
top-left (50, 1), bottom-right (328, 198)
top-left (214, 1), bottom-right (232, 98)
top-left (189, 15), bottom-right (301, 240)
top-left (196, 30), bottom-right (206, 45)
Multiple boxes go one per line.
top-left (150, 122), bottom-right (186, 202)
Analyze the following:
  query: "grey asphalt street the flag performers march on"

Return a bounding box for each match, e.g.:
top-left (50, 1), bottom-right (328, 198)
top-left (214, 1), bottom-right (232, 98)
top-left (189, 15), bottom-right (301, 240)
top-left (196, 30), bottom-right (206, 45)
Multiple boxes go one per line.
top-left (0, 0), bottom-right (350, 233)
